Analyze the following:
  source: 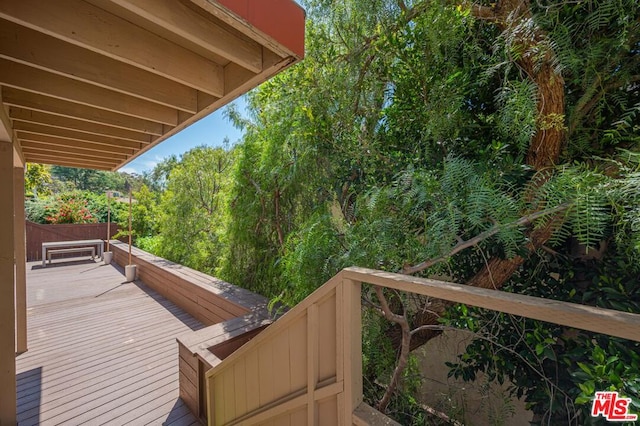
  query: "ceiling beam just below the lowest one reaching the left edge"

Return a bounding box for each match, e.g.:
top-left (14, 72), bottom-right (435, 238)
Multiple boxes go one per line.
top-left (9, 107), bottom-right (154, 143)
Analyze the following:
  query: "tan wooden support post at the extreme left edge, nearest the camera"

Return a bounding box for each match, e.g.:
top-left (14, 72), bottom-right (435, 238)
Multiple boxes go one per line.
top-left (0, 140), bottom-right (16, 426)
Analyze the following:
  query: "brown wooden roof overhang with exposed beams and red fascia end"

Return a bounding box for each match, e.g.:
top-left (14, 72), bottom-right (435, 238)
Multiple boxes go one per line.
top-left (0, 0), bottom-right (305, 170)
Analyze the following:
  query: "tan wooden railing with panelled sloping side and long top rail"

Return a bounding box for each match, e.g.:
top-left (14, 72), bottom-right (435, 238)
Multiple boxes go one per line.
top-left (206, 268), bottom-right (640, 425)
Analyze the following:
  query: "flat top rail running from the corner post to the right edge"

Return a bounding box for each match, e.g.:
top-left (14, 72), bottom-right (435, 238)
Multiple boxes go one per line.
top-left (342, 268), bottom-right (640, 342)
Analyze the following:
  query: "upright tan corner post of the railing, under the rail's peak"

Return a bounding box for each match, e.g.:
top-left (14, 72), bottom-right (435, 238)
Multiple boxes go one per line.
top-left (341, 279), bottom-right (362, 426)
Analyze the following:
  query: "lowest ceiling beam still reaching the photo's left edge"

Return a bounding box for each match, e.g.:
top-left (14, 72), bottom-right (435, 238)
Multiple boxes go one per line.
top-left (3, 87), bottom-right (166, 136)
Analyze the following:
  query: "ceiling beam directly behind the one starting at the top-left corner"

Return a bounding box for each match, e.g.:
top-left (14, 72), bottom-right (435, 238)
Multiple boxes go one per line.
top-left (0, 19), bottom-right (197, 114)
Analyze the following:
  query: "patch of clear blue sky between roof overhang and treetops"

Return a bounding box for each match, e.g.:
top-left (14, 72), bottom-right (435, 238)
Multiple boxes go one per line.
top-left (119, 96), bottom-right (246, 174)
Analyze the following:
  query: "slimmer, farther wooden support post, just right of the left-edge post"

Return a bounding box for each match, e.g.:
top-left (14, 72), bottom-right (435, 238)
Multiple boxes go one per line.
top-left (13, 162), bottom-right (27, 354)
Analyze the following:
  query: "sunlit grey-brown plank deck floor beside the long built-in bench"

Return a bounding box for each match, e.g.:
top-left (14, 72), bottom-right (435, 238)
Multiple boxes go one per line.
top-left (17, 260), bottom-right (202, 426)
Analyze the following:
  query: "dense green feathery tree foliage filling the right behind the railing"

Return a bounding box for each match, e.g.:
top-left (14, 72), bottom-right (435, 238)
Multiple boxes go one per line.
top-left (27, 0), bottom-right (640, 424)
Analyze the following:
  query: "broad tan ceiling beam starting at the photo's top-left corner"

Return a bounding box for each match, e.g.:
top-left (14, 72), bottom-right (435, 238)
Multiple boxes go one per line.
top-left (0, 0), bottom-right (223, 97)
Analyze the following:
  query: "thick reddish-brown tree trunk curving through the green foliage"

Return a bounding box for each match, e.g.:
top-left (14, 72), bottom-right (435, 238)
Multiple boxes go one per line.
top-left (389, 0), bottom-right (565, 350)
